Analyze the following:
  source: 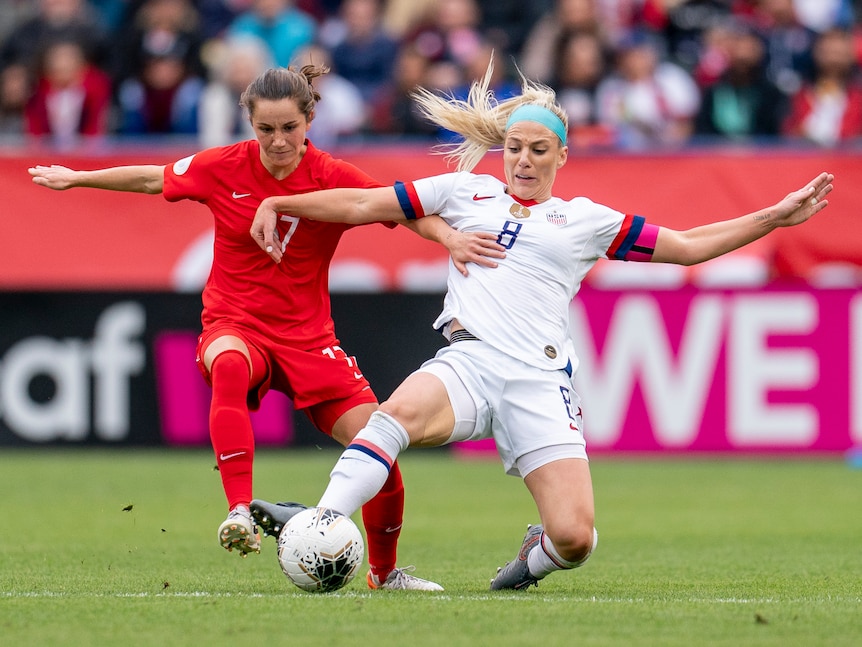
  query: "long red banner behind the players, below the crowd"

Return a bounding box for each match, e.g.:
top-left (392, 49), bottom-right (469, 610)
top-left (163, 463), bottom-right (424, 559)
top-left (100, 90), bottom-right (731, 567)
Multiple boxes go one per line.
top-left (0, 148), bottom-right (862, 291)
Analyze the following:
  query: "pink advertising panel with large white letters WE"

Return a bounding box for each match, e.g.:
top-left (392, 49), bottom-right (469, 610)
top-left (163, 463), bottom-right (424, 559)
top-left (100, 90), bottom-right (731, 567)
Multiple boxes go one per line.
top-left (458, 287), bottom-right (862, 453)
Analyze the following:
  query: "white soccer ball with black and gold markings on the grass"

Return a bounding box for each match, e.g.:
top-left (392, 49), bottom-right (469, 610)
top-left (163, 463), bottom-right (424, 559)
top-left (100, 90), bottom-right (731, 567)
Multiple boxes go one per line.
top-left (278, 508), bottom-right (365, 593)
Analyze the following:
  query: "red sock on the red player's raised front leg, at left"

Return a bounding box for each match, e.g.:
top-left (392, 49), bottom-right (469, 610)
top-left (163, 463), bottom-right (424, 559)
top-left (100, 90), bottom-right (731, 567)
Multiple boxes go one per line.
top-left (210, 350), bottom-right (254, 510)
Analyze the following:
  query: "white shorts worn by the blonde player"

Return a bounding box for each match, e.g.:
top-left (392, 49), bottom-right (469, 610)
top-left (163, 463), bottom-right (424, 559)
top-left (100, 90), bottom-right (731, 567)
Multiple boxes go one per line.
top-left (417, 340), bottom-right (587, 477)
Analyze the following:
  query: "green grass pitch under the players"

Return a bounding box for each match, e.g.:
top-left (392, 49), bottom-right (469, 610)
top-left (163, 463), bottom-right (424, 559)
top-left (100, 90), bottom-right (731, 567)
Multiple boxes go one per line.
top-left (0, 449), bottom-right (862, 647)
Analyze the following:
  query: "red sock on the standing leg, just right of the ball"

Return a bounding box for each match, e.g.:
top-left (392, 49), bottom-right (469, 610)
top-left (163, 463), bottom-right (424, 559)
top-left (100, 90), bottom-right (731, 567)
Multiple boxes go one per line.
top-left (362, 462), bottom-right (404, 580)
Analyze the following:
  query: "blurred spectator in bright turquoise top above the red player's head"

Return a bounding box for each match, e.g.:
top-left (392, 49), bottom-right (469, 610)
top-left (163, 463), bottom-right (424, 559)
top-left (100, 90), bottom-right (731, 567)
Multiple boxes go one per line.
top-left (227, 0), bottom-right (317, 67)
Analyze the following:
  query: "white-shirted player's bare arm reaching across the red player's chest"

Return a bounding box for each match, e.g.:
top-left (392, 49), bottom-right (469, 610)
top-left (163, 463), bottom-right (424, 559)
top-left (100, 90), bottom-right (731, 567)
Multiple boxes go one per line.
top-left (249, 186), bottom-right (406, 263)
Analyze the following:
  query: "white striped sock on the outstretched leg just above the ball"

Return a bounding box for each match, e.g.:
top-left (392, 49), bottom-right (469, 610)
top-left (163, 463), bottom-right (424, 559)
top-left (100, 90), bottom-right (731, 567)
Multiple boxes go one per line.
top-left (317, 411), bottom-right (410, 516)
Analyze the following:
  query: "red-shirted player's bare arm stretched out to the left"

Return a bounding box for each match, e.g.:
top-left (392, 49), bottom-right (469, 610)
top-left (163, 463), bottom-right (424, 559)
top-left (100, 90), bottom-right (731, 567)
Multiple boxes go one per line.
top-left (28, 164), bottom-right (165, 193)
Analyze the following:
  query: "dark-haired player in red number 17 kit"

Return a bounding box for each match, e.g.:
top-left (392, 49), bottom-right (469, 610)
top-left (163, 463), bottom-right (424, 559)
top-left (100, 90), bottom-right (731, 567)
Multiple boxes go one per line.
top-left (29, 65), bottom-right (503, 590)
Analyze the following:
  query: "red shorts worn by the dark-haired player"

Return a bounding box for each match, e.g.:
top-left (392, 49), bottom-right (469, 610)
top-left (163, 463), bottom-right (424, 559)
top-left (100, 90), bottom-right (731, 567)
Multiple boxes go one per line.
top-left (202, 325), bottom-right (377, 435)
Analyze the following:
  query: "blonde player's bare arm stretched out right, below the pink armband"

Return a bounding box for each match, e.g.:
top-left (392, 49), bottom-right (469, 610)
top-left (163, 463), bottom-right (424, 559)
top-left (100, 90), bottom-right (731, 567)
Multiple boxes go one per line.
top-left (652, 173), bottom-right (834, 265)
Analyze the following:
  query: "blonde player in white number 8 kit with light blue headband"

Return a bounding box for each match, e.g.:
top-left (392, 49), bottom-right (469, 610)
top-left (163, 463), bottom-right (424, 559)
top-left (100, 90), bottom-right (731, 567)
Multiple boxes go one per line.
top-left (251, 63), bottom-right (833, 590)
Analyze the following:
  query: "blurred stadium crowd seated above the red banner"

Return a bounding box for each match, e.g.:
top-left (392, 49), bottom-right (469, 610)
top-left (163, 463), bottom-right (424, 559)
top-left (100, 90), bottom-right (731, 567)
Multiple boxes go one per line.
top-left (0, 0), bottom-right (862, 150)
